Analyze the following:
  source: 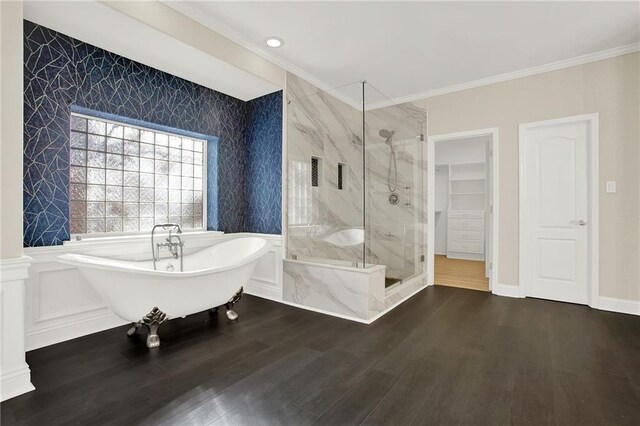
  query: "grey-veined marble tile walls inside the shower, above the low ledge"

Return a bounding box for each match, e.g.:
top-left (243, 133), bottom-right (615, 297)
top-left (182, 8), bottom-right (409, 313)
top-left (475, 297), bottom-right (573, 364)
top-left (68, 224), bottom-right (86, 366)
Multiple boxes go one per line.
top-left (287, 74), bottom-right (426, 279)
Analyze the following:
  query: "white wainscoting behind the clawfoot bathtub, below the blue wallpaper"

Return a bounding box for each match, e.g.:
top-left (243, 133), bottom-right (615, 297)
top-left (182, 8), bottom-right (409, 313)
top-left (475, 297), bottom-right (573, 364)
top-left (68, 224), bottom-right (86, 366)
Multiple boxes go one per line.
top-left (25, 232), bottom-right (282, 351)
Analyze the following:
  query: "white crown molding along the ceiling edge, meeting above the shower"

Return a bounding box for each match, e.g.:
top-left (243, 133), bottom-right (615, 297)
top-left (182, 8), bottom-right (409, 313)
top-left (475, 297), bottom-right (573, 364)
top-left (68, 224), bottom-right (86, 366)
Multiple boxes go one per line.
top-left (159, 0), bottom-right (640, 110)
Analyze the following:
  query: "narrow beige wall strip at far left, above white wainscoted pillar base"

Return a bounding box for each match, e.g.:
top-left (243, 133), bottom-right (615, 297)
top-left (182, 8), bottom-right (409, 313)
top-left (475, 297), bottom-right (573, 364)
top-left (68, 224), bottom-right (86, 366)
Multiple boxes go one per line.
top-left (0, 1), bottom-right (23, 259)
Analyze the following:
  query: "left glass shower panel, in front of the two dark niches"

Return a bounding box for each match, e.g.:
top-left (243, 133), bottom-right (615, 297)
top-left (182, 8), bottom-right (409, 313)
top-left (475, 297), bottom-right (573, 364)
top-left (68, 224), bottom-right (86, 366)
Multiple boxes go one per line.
top-left (286, 74), bottom-right (365, 267)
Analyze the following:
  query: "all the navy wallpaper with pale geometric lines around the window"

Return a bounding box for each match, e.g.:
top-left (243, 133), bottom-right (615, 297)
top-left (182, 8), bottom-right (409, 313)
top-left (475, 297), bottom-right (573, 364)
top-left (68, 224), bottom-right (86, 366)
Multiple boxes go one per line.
top-left (24, 21), bottom-right (282, 246)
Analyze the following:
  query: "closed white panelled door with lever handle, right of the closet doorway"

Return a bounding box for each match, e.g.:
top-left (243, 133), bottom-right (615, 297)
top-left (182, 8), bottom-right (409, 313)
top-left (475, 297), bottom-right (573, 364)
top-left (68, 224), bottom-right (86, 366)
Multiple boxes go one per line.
top-left (520, 119), bottom-right (591, 304)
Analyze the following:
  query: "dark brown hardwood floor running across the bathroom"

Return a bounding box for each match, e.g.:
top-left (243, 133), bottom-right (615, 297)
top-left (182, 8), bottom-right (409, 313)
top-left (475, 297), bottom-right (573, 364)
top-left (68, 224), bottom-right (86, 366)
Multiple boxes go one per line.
top-left (0, 287), bottom-right (640, 426)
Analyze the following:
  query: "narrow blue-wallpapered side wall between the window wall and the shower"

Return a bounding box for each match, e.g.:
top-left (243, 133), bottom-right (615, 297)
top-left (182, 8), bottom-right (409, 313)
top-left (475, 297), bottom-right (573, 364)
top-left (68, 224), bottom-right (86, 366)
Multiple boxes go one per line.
top-left (245, 92), bottom-right (282, 234)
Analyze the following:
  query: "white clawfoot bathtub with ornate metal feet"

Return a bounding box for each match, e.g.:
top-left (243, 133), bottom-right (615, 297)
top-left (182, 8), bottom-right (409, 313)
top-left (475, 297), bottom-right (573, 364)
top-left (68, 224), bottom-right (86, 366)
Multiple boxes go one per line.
top-left (58, 237), bottom-right (271, 348)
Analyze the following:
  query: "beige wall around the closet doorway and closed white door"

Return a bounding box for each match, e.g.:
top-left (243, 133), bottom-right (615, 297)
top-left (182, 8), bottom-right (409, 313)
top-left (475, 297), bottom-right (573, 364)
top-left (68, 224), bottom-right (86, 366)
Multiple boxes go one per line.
top-left (416, 53), bottom-right (640, 300)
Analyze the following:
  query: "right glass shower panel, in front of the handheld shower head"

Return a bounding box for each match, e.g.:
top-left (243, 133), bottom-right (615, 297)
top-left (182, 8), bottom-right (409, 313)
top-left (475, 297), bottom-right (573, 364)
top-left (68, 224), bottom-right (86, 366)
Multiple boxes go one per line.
top-left (365, 85), bottom-right (426, 287)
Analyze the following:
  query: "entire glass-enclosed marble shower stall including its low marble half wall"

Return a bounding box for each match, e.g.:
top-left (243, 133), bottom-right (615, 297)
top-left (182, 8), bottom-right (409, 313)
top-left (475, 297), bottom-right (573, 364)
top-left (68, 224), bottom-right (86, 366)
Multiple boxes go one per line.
top-left (283, 74), bottom-right (427, 322)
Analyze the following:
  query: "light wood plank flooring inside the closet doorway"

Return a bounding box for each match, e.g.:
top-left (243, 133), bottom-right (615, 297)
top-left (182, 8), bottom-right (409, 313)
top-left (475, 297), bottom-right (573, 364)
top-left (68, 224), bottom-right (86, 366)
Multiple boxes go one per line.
top-left (433, 255), bottom-right (489, 291)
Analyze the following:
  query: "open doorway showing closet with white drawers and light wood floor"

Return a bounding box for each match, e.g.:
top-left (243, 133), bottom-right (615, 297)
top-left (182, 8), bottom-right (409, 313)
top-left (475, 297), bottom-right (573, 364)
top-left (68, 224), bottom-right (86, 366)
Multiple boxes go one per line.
top-left (427, 129), bottom-right (498, 291)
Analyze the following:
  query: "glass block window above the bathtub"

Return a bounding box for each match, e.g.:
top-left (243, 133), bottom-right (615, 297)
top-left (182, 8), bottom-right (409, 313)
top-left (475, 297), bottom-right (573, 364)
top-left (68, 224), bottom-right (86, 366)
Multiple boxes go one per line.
top-left (69, 113), bottom-right (206, 234)
